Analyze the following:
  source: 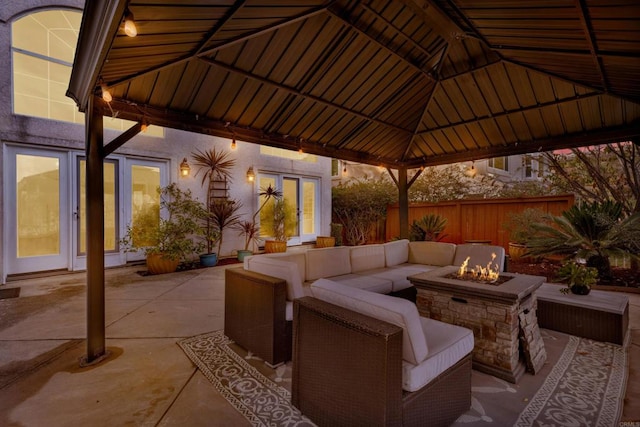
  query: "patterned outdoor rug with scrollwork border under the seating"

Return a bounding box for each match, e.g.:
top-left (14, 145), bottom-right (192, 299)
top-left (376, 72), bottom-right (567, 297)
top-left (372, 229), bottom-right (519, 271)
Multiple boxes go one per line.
top-left (178, 329), bottom-right (628, 427)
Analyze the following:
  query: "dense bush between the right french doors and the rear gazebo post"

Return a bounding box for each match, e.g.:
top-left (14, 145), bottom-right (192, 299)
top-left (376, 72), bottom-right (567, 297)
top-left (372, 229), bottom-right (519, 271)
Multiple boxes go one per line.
top-left (331, 178), bottom-right (398, 245)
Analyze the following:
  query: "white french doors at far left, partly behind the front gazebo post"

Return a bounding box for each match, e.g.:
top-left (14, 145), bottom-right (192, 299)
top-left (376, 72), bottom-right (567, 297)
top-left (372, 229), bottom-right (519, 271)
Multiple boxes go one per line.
top-left (2, 146), bottom-right (168, 280)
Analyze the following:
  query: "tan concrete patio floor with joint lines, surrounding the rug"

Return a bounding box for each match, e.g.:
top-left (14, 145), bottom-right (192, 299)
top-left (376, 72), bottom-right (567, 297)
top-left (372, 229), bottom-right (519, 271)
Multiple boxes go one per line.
top-left (0, 266), bottom-right (640, 426)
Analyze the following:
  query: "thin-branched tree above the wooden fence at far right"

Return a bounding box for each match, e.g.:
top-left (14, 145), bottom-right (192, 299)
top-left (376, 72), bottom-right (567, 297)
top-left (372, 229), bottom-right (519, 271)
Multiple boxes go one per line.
top-left (544, 141), bottom-right (640, 215)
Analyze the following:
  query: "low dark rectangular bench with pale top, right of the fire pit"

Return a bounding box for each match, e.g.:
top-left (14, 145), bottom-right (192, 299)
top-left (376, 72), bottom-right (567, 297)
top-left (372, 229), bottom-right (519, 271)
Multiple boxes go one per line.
top-left (536, 283), bottom-right (629, 345)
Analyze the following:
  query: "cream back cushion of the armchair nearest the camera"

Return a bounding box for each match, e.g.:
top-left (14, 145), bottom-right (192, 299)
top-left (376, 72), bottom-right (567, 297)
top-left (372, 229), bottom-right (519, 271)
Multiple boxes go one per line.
top-left (311, 279), bottom-right (429, 365)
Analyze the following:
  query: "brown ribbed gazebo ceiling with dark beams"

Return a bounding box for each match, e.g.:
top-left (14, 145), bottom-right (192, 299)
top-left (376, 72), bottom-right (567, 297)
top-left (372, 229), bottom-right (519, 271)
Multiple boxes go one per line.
top-left (69, 0), bottom-right (640, 168)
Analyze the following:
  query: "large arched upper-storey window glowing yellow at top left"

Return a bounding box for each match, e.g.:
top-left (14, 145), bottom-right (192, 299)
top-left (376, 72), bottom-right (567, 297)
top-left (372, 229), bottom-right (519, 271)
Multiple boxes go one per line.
top-left (11, 9), bottom-right (164, 137)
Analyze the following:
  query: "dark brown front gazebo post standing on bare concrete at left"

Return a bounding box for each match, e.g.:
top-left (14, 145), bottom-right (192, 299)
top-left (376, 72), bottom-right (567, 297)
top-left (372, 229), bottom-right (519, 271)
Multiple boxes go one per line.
top-left (81, 95), bottom-right (107, 365)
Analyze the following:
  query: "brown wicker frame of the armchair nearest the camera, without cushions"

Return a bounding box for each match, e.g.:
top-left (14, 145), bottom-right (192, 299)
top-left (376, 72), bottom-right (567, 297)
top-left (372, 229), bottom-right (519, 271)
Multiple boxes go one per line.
top-left (292, 297), bottom-right (471, 427)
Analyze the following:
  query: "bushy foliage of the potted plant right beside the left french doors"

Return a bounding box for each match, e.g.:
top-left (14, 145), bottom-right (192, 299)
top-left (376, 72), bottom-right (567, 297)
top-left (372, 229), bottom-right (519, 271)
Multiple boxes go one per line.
top-left (120, 183), bottom-right (203, 261)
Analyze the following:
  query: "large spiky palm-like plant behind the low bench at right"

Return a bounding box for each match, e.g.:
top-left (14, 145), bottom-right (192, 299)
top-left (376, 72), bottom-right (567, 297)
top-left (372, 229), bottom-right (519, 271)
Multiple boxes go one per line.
top-left (527, 201), bottom-right (640, 279)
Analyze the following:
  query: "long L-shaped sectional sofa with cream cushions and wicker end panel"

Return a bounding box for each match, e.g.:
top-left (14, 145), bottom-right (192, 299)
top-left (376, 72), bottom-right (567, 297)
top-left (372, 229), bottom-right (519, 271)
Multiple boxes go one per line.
top-left (224, 240), bottom-right (504, 365)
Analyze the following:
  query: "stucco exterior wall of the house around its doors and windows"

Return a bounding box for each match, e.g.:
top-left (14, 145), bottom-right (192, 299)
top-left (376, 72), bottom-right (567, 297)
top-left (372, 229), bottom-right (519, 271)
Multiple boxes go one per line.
top-left (0, 0), bottom-right (331, 283)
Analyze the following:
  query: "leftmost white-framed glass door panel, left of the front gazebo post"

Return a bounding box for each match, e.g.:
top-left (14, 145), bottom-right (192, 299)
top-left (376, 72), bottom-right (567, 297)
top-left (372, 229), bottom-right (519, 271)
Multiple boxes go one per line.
top-left (4, 147), bottom-right (70, 274)
